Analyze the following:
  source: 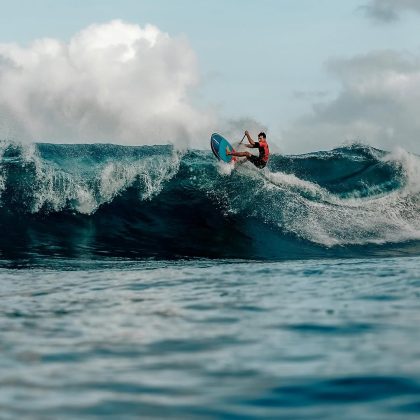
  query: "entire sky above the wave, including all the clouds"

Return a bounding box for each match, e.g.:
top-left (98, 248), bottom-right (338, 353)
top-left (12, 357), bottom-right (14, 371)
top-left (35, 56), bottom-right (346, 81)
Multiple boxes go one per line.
top-left (0, 0), bottom-right (420, 153)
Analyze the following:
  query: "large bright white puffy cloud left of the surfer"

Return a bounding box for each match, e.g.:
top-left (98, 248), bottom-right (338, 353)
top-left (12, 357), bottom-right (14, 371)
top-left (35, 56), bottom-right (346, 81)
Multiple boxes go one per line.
top-left (0, 20), bottom-right (217, 145)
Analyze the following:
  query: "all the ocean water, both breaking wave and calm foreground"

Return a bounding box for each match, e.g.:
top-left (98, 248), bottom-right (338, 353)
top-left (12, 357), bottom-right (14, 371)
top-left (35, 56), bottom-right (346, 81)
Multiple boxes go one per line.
top-left (0, 142), bottom-right (420, 419)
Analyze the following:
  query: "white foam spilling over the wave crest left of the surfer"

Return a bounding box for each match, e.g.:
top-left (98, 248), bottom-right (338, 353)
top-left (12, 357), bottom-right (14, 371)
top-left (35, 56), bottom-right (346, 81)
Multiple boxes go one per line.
top-left (5, 145), bottom-right (182, 214)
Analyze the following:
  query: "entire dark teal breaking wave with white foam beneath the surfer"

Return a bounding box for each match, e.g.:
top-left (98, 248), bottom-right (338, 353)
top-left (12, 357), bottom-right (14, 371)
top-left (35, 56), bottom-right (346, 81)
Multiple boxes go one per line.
top-left (0, 142), bottom-right (420, 259)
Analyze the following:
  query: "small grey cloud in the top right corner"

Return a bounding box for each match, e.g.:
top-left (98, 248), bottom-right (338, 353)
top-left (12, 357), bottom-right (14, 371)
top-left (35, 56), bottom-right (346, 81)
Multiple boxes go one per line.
top-left (362, 0), bottom-right (420, 22)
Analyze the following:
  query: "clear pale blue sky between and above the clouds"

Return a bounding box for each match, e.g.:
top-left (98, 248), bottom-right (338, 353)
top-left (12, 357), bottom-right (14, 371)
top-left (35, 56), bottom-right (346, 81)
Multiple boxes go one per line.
top-left (0, 0), bottom-right (420, 152)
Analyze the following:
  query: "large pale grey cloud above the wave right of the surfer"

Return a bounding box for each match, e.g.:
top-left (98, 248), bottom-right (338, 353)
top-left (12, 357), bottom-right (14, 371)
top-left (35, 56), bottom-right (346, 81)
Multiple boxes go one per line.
top-left (283, 51), bottom-right (420, 153)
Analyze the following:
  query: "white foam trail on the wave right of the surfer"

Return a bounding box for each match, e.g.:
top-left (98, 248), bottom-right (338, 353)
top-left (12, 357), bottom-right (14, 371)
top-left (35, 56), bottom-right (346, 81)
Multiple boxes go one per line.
top-left (226, 149), bottom-right (420, 247)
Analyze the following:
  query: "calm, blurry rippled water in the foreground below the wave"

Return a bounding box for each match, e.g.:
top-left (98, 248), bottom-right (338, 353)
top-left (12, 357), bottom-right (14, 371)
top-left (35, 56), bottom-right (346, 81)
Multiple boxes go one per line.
top-left (0, 257), bottom-right (420, 419)
